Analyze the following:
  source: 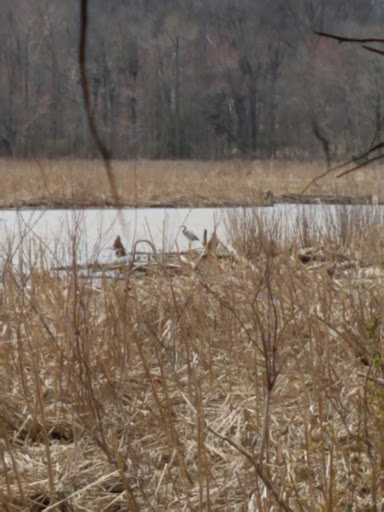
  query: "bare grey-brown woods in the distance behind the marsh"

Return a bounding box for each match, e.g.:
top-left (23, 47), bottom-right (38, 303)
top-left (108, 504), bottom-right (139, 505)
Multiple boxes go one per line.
top-left (0, 0), bottom-right (384, 160)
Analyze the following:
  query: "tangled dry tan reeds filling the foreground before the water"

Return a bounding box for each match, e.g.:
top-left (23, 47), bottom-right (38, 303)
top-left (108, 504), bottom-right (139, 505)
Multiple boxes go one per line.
top-left (0, 207), bottom-right (384, 512)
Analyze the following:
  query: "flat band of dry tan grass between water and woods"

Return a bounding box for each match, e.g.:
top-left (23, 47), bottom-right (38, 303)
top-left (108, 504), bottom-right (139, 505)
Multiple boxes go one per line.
top-left (0, 159), bottom-right (384, 207)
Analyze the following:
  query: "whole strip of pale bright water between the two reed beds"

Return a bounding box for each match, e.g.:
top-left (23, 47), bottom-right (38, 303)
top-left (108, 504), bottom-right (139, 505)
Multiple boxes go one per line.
top-left (0, 204), bottom-right (384, 265)
